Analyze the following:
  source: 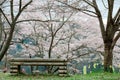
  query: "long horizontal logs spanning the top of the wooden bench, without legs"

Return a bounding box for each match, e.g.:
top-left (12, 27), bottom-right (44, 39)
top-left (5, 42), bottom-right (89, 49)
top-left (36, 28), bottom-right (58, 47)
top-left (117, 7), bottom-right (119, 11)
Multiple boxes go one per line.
top-left (9, 58), bottom-right (67, 66)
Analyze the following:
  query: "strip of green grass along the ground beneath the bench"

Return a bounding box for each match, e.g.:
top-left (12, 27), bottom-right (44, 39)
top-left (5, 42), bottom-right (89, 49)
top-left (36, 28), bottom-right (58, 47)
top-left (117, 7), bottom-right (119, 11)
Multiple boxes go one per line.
top-left (0, 73), bottom-right (120, 80)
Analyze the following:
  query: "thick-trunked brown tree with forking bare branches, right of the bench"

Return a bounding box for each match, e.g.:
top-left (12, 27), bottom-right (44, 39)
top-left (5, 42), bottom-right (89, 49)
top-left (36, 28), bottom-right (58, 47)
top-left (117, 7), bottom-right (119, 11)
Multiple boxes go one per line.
top-left (57, 0), bottom-right (120, 72)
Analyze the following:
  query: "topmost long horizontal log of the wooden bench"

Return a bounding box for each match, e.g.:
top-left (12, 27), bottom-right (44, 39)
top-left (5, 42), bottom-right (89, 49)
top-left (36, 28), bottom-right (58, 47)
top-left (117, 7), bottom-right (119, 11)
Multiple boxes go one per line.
top-left (9, 58), bottom-right (67, 62)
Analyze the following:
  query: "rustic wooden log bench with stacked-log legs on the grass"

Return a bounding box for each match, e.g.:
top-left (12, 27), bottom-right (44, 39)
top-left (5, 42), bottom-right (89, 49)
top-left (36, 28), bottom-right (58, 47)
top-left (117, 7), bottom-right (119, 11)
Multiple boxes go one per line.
top-left (9, 58), bottom-right (67, 76)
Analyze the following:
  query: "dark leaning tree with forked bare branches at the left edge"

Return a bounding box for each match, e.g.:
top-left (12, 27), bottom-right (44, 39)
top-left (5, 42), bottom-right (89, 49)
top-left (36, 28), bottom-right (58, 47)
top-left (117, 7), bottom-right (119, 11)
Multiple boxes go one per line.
top-left (0, 0), bottom-right (32, 61)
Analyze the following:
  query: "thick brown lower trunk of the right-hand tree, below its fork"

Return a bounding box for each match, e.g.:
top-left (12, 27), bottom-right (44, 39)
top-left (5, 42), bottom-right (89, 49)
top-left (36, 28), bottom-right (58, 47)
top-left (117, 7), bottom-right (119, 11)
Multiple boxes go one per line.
top-left (104, 43), bottom-right (113, 73)
